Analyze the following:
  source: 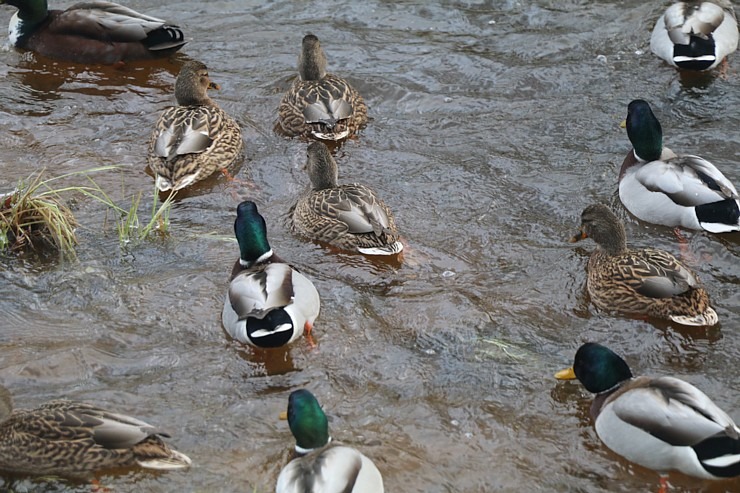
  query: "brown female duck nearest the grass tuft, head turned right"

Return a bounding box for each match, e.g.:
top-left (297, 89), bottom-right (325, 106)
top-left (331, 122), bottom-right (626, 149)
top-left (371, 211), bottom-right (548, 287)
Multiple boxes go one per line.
top-left (147, 62), bottom-right (242, 192)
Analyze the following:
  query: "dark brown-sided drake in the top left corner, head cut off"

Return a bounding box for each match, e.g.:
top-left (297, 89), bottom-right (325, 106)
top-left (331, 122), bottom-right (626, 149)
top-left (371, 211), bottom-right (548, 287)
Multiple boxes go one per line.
top-left (0, 0), bottom-right (186, 64)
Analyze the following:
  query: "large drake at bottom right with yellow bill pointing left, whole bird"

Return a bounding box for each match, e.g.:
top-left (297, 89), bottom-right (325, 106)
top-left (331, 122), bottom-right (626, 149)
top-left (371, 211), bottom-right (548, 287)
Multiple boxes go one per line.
top-left (555, 343), bottom-right (740, 479)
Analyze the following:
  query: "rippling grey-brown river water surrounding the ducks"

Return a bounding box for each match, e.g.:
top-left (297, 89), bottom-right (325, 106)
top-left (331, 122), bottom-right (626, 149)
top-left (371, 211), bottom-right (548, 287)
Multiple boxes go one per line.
top-left (0, 0), bottom-right (740, 493)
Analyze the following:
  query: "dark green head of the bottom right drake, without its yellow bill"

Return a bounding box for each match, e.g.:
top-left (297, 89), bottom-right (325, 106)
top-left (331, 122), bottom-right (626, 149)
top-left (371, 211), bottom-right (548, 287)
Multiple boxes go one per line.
top-left (573, 342), bottom-right (632, 394)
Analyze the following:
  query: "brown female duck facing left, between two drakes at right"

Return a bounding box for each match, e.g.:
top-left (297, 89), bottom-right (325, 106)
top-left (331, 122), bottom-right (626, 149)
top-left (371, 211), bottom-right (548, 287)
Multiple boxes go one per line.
top-left (571, 204), bottom-right (717, 326)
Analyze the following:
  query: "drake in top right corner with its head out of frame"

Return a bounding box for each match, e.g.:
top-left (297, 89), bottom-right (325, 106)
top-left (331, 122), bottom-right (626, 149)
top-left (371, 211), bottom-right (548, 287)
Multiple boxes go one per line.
top-left (650, 0), bottom-right (738, 70)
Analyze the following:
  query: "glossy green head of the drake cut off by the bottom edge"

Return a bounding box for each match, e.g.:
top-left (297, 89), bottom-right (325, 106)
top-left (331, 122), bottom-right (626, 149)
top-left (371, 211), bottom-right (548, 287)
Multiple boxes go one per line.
top-left (288, 389), bottom-right (331, 452)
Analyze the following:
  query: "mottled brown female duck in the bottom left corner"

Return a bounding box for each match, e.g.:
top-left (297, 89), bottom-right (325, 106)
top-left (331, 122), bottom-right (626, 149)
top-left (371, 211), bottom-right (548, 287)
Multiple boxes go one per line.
top-left (0, 387), bottom-right (191, 477)
